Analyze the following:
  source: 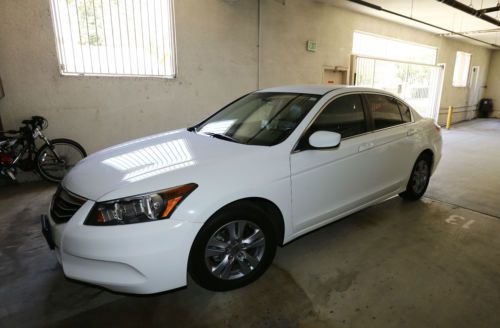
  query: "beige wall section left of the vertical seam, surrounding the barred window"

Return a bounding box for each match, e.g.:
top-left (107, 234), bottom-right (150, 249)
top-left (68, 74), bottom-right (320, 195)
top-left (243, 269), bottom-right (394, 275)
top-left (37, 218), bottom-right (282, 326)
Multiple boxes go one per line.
top-left (0, 0), bottom-right (258, 152)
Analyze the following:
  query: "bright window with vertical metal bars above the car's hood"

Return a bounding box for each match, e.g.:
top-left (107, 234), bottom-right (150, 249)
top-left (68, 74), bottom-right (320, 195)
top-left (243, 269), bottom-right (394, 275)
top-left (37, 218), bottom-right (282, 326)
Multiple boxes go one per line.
top-left (51, 0), bottom-right (176, 78)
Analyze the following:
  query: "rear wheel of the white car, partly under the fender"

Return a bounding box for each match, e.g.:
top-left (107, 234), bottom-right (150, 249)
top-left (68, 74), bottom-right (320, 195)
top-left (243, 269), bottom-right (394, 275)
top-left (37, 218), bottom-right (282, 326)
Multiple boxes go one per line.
top-left (399, 153), bottom-right (432, 201)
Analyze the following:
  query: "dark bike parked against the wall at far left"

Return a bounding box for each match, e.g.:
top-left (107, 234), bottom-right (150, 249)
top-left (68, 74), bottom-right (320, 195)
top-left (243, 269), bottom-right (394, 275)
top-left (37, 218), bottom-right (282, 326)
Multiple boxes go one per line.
top-left (0, 116), bottom-right (87, 182)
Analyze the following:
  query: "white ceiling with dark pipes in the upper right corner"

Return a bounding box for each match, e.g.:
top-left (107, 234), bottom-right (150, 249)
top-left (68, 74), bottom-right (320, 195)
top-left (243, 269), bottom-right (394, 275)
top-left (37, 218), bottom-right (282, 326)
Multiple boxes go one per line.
top-left (318, 0), bottom-right (500, 49)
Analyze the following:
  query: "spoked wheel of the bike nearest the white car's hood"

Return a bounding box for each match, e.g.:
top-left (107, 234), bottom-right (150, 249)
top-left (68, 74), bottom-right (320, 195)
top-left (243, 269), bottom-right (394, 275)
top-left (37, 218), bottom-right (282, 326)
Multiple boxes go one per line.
top-left (35, 139), bottom-right (87, 182)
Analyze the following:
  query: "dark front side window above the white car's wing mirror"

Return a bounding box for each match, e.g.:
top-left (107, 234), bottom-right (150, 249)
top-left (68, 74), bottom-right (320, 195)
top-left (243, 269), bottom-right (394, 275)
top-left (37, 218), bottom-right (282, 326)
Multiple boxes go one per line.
top-left (310, 95), bottom-right (366, 138)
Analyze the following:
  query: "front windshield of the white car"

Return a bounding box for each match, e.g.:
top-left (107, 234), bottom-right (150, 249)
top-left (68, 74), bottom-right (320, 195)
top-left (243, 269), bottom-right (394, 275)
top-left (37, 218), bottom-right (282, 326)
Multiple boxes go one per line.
top-left (194, 92), bottom-right (321, 146)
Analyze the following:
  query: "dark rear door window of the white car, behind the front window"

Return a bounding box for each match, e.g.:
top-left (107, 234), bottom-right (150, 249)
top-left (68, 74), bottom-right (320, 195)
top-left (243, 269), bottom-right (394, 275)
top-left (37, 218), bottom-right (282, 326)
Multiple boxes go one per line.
top-left (366, 94), bottom-right (403, 129)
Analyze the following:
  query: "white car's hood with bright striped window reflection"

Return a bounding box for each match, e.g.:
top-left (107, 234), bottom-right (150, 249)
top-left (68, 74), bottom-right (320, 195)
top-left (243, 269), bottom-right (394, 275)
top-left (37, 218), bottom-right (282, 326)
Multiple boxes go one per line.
top-left (62, 129), bottom-right (270, 201)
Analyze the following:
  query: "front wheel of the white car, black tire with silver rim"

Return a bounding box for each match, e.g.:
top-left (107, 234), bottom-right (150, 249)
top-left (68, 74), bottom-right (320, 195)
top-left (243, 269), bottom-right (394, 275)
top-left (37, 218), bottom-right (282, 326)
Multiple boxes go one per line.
top-left (188, 202), bottom-right (277, 291)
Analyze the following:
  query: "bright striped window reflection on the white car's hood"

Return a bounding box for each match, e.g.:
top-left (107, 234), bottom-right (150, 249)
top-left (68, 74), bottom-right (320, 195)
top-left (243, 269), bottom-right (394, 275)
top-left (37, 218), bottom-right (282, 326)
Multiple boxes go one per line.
top-left (103, 139), bottom-right (196, 182)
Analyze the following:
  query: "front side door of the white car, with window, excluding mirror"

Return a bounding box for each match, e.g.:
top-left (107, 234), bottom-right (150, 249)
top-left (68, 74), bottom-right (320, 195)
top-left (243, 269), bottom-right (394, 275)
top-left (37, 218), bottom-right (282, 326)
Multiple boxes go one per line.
top-left (290, 94), bottom-right (378, 233)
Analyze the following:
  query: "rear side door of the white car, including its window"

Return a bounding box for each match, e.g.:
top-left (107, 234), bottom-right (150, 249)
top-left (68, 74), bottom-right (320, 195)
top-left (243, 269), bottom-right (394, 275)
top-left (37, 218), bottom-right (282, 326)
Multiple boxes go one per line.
top-left (365, 93), bottom-right (418, 196)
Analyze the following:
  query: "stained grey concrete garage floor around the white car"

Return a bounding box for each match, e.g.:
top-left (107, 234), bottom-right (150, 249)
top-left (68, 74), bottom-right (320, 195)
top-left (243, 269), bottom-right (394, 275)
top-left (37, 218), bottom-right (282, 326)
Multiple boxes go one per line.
top-left (0, 120), bottom-right (500, 328)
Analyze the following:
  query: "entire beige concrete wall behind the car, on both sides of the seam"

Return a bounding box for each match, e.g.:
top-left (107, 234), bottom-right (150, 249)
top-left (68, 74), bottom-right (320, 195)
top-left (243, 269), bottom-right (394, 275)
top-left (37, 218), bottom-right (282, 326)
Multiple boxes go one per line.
top-left (0, 0), bottom-right (491, 152)
